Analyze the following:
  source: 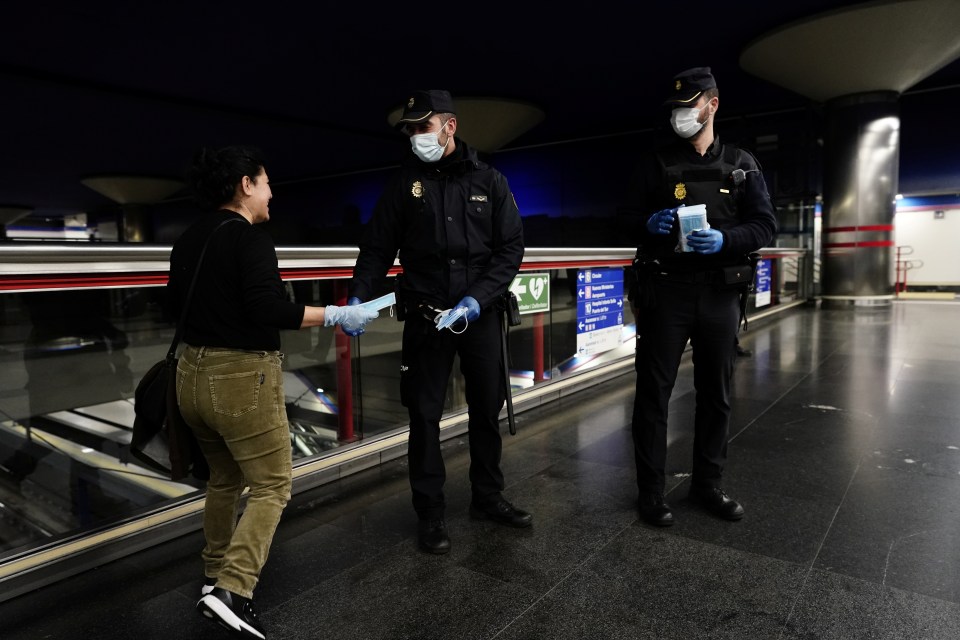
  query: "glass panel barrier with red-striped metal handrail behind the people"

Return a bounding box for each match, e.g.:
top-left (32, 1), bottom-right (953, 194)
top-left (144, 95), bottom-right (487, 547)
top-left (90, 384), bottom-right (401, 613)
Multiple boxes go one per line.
top-left (0, 245), bottom-right (809, 597)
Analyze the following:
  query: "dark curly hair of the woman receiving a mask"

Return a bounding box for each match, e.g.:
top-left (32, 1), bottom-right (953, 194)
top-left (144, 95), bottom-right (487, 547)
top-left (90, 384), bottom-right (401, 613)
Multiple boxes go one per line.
top-left (187, 145), bottom-right (263, 211)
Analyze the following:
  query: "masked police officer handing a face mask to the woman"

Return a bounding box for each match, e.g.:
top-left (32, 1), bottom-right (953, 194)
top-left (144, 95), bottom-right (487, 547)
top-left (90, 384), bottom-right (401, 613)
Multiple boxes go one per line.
top-left (349, 90), bottom-right (532, 553)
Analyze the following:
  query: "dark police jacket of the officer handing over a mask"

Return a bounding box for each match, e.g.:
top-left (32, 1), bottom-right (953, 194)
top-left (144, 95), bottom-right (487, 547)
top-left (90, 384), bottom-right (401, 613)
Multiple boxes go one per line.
top-left (350, 138), bottom-right (523, 309)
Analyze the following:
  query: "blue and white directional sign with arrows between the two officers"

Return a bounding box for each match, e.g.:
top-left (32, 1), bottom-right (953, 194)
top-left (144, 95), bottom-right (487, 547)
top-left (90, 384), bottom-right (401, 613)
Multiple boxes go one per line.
top-left (577, 267), bottom-right (623, 355)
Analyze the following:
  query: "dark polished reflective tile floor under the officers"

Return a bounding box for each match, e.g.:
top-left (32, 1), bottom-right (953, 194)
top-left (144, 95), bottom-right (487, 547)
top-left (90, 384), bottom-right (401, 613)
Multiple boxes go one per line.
top-left (0, 302), bottom-right (960, 640)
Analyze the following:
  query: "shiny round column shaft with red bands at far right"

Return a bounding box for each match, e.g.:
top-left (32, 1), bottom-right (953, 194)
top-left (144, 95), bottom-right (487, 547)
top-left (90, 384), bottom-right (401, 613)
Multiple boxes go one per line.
top-left (821, 91), bottom-right (900, 307)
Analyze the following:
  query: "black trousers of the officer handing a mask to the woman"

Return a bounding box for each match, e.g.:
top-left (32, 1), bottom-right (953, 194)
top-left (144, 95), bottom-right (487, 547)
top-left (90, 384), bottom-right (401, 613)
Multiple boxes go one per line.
top-left (400, 310), bottom-right (506, 520)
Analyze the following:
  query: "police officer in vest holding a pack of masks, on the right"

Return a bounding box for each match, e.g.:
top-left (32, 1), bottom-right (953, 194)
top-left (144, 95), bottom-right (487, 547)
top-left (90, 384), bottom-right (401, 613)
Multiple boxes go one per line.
top-left (623, 67), bottom-right (777, 526)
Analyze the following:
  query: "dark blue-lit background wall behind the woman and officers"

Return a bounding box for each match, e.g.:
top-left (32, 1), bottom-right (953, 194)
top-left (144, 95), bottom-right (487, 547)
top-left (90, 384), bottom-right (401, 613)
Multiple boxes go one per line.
top-left (141, 88), bottom-right (960, 247)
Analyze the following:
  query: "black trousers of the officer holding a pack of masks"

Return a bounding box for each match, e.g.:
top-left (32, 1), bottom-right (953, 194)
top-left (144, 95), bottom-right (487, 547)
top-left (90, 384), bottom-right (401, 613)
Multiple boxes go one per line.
top-left (633, 276), bottom-right (740, 494)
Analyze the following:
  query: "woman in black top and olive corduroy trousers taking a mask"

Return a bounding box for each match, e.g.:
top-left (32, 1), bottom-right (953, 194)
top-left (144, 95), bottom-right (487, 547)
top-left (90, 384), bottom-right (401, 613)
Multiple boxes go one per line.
top-left (167, 146), bottom-right (377, 638)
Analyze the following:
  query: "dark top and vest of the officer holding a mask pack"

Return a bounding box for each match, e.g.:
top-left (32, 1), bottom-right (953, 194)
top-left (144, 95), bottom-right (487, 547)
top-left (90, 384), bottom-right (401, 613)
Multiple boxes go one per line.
top-left (621, 137), bottom-right (777, 273)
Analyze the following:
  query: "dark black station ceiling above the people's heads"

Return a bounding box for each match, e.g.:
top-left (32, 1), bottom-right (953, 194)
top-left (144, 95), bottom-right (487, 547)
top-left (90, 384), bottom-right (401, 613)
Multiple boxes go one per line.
top-left (0, 0), bottom-right (960, 220)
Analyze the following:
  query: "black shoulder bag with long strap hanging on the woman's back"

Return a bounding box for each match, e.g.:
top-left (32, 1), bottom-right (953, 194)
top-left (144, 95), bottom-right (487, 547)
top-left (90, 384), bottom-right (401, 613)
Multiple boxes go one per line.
top-left (130, 219), bottom-right (240, 480)
